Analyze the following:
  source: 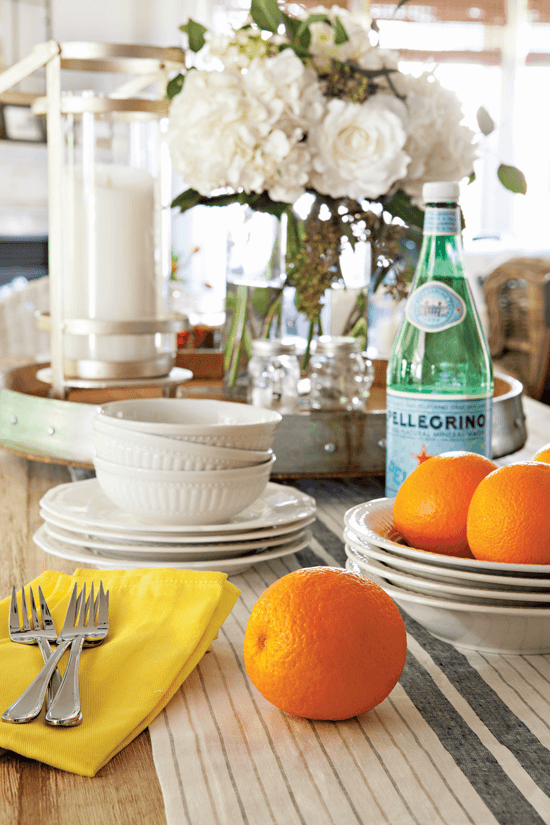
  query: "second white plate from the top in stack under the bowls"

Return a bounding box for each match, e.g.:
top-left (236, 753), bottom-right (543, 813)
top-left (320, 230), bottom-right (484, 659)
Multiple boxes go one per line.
top-left (40, 510), bottom-right (315, 546)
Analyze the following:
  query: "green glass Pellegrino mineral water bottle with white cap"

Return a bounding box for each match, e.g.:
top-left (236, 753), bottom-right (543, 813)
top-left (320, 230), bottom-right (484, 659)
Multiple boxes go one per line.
top-left (386, 183), bottom-right (493, 497)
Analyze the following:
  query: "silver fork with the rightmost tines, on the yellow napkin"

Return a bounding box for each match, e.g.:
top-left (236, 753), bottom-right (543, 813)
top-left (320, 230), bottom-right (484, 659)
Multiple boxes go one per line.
top-left (46, 582), bottom-right (109, 727)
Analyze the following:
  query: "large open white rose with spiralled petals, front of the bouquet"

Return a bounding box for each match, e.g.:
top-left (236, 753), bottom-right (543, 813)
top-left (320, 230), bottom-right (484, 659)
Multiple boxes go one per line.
top-left (308, 98), bottom-right (409, 200)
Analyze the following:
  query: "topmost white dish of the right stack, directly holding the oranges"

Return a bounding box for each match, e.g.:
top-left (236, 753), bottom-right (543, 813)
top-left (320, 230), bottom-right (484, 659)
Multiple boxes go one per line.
top-left (344, 498), bottom-right (550, 578)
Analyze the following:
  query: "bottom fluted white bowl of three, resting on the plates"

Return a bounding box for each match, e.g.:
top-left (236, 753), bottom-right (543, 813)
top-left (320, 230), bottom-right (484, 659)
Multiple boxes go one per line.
top-left (94, 456), bottom-right (275, 525)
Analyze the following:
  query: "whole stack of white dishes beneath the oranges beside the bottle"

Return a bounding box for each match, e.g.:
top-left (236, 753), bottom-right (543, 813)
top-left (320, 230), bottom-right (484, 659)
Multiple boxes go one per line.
top-left (344, 498), bottom-right (550, 653)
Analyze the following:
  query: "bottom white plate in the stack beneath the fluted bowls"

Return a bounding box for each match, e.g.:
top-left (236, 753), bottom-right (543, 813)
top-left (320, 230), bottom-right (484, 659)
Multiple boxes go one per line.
top-left (33, 524), bottom-right (311, 576)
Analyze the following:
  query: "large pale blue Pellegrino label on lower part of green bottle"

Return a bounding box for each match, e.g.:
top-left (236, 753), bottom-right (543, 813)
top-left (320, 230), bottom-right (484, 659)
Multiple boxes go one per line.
top-left (386, 389), bottom-right (493, 497)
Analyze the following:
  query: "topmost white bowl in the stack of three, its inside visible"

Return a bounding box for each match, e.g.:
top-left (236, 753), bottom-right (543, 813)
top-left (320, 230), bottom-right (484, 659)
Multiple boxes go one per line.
top-left (99, 398), bottom-right (282, 450)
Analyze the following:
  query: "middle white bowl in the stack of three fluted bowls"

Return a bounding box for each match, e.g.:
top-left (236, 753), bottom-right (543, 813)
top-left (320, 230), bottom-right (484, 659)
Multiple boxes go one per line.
top-left (93, 416), bottom-right (273, 470)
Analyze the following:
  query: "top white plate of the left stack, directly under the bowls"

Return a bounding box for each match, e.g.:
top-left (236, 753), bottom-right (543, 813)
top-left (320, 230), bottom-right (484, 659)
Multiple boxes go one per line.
top-left (40, 478), bottom-right (316, 538)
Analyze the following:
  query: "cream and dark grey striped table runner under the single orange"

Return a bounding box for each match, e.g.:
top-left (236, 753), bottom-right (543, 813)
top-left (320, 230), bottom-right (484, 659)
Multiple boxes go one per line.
top-left (149, 479), bottom-right (550, 825)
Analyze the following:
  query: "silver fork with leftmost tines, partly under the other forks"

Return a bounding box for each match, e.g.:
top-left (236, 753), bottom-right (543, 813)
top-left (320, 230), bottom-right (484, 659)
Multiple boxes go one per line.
top-left (9, 585), bottom-right (61, 707)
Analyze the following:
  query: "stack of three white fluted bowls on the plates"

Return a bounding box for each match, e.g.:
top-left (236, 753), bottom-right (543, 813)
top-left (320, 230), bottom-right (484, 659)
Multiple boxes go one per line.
top-left (93, 398), bottom-right (281, 526)
